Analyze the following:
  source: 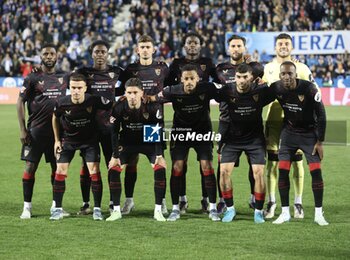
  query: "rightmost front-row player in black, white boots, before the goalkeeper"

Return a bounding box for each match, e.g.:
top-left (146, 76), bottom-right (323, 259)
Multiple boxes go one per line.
top-left (270, 61), bottom-right (328, 226)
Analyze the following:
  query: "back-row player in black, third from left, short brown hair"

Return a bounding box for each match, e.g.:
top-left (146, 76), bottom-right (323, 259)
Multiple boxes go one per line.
top-left (122, 35), bottom-right (168, 214)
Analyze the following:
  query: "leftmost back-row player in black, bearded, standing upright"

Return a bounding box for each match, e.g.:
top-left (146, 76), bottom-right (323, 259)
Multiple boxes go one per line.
top-left (17, 43), bottom-right (68, 219)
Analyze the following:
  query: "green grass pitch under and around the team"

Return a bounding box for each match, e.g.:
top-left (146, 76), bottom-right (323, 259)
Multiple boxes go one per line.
top-left (0, 105), bottom-right (350, 259)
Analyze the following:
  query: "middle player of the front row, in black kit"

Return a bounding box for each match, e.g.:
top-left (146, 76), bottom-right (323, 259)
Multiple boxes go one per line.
top-left (156, 64), bottom-right (220, 221)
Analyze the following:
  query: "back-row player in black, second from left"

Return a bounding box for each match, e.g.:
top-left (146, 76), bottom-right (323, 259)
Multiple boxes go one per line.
top-left (77, 40), bottom-right (123, 215)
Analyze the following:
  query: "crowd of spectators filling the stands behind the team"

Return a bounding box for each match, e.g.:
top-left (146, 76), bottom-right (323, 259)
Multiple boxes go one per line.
top-left (0, 0), bottom-right (350, 86)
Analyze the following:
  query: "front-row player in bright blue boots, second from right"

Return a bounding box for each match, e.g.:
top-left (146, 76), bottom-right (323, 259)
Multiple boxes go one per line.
top-left (220, 63), bottom-right (274, 223)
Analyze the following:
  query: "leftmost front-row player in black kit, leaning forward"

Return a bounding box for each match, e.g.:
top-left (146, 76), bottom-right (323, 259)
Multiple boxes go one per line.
top-left (50, 73), bottom-right (113, 220)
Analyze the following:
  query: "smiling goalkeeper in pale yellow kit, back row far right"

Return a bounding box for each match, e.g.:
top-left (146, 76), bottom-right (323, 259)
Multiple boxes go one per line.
top-left (263, 33), bottom-right (316, 218)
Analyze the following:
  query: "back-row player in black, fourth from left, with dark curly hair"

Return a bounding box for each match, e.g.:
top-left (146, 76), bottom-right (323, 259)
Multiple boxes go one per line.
top-left (166, 32), bottom-right (215, 213)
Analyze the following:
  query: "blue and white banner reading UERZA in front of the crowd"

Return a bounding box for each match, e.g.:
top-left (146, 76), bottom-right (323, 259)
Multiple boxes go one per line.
top-left (226, 31), bottom-right (350, 55)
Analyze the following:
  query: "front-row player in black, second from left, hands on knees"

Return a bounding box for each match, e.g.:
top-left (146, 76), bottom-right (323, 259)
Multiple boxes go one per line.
top-left (107, 78), bottom-right (166, 221)
